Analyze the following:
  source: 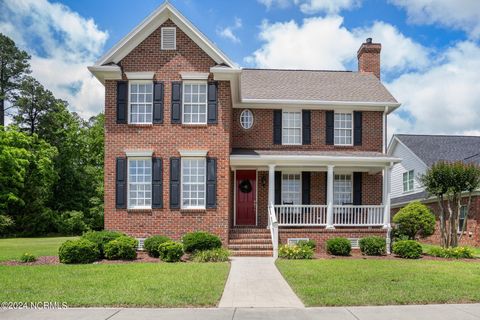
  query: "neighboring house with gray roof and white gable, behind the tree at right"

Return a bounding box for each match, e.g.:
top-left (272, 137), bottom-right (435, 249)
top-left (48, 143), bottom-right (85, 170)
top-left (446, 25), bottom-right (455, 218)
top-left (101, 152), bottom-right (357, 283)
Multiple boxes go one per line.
top-left (388, 134), bottom-right (480, 246)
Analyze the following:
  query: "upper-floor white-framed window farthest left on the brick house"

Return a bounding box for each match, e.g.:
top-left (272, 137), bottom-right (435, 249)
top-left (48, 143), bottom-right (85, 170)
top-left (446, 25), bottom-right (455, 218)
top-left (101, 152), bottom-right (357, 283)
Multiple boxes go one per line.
top-left (129, 80), bottom-right (153, 123)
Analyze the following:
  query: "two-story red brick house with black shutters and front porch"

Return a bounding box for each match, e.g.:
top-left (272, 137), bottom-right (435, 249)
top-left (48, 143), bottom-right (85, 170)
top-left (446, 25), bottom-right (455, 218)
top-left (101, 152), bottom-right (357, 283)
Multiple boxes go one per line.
top-left (89, 3), bottom-right (399, 255)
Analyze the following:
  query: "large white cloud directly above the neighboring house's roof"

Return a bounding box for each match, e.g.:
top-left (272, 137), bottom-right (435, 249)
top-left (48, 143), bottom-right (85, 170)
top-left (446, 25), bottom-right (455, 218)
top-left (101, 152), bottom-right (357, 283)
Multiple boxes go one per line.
top-left (386, 41), bottom-right (480, 135)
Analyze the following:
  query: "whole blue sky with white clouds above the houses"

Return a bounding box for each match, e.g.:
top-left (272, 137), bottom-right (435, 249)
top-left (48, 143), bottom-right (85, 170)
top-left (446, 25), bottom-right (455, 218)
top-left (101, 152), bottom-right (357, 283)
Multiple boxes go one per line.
top-left (0, 0), bottom-right (480, 135)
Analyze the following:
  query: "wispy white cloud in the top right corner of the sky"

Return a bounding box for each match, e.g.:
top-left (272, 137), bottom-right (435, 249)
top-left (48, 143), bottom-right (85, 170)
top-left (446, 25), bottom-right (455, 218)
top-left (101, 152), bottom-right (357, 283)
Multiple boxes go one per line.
top-left (390, 0), bottom-right (480, 39)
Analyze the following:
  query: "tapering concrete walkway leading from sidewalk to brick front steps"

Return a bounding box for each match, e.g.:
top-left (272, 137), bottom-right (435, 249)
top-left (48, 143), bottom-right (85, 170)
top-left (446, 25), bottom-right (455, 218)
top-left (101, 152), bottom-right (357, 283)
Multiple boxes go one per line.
top-left (219, 257), bottom-right (303, 308)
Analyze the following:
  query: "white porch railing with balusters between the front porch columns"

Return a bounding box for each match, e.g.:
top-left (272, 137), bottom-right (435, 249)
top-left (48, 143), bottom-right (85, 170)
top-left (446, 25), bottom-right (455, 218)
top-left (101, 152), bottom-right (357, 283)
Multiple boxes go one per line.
top-left (276, 205), bottom-right (384, 227)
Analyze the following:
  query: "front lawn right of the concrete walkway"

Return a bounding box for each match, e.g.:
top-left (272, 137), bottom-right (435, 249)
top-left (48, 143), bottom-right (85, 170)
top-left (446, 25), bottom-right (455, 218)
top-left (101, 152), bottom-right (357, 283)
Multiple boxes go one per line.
top-left (277, 259), bottom-right (480, 306)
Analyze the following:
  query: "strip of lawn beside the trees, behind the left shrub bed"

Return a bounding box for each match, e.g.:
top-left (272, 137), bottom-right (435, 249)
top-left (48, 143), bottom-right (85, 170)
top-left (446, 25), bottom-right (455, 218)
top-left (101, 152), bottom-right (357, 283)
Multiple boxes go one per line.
top-left (0, 237), bottom-right (75, 261)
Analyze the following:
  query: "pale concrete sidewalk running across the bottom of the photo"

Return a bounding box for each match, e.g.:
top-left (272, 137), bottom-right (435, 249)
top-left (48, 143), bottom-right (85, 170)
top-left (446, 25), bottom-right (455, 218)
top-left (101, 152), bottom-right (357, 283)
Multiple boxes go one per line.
top-left (0, 304), bottom-right (480, 320)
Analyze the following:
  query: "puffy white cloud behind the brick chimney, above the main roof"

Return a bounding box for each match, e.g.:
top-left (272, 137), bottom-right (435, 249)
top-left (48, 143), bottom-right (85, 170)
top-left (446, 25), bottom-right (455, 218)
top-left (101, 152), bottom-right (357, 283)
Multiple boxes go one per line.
top-left (246, 16), bottom-right (428, 72)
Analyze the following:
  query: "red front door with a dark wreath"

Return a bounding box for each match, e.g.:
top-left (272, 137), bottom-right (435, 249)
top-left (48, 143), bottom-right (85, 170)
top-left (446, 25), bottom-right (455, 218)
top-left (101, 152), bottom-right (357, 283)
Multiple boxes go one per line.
top-left (235, 170), bottom-right (257, 226)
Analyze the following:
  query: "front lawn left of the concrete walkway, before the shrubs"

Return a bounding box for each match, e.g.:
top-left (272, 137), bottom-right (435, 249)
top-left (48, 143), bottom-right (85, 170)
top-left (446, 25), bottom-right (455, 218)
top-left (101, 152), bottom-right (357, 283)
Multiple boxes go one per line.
top-left (0, 263), bottom-right (229, 307)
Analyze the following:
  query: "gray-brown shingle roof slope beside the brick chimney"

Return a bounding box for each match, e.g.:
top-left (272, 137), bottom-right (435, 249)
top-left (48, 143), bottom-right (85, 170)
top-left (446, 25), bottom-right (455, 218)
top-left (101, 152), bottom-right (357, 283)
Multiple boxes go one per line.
top-left (240, 69), bottom-right (397, 103)
